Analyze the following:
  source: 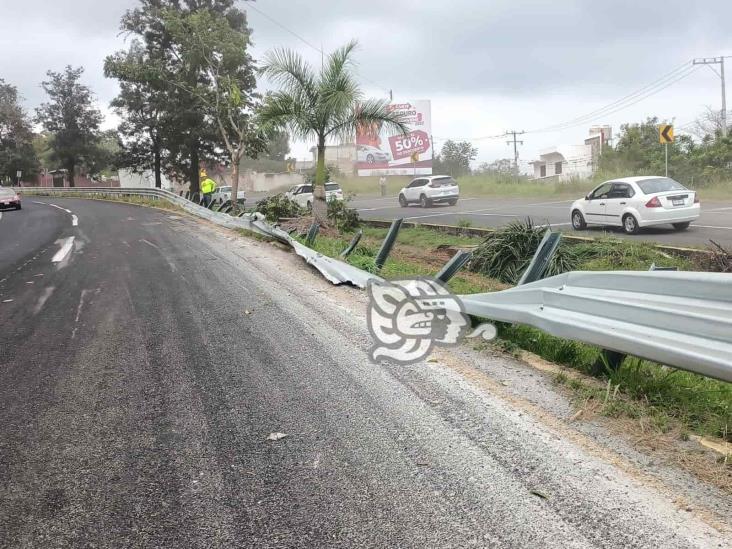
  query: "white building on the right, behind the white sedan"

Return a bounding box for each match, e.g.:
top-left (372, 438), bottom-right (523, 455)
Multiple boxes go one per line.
top-left (531, 126), bottom-right (612, 181)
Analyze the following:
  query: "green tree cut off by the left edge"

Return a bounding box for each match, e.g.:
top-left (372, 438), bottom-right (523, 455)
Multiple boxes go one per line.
top-left (0, 78), bottom-right (39, 181)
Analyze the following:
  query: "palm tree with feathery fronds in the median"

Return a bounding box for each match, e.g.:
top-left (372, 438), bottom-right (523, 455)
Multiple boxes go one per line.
top-left (259, 41), bottom-right (409, 224)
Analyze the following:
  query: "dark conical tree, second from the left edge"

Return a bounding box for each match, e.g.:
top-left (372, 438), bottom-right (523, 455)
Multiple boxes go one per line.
top-left (36, 66), bottom-right (102, 187)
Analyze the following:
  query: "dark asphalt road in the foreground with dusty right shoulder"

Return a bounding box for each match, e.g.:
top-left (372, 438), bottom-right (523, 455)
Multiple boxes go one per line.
top-left (0, 199), bottom-right (730, 548)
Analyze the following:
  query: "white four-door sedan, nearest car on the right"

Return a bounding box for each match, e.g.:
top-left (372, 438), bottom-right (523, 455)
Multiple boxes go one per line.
top-left (570, 176), bottom-right (701, 234)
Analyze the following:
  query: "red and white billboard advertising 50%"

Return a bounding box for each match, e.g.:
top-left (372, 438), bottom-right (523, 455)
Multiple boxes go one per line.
top-left (356, 100), bottom-right (432, 176)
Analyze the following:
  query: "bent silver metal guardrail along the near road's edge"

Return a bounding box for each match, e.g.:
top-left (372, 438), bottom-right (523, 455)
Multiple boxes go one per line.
top-left (18, 188), bottom-right (732, 382)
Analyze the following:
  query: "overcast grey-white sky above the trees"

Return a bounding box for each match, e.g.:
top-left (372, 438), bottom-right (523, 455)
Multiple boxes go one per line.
top-left (0, 0), bottom-right (732, 167)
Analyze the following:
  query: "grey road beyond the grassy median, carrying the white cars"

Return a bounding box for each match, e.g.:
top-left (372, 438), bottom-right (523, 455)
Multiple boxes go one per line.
top-left (352, 197), bottom-right (732, 247)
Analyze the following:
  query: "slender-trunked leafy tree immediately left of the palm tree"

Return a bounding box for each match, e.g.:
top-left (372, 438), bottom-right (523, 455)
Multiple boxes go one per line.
top-left (163, 10), bottom-right (266, 209)
